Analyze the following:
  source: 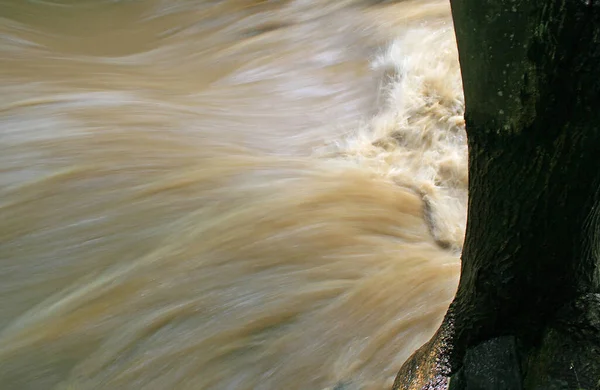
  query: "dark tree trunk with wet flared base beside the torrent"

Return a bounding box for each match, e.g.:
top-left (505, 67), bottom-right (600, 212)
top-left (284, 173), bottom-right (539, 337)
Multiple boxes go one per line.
top-left (394, 0), bottom-right (600, 390)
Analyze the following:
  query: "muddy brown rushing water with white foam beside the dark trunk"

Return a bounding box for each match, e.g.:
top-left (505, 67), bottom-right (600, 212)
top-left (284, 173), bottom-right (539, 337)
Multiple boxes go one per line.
top-left (0, 0), bottom-right (467, 390)
